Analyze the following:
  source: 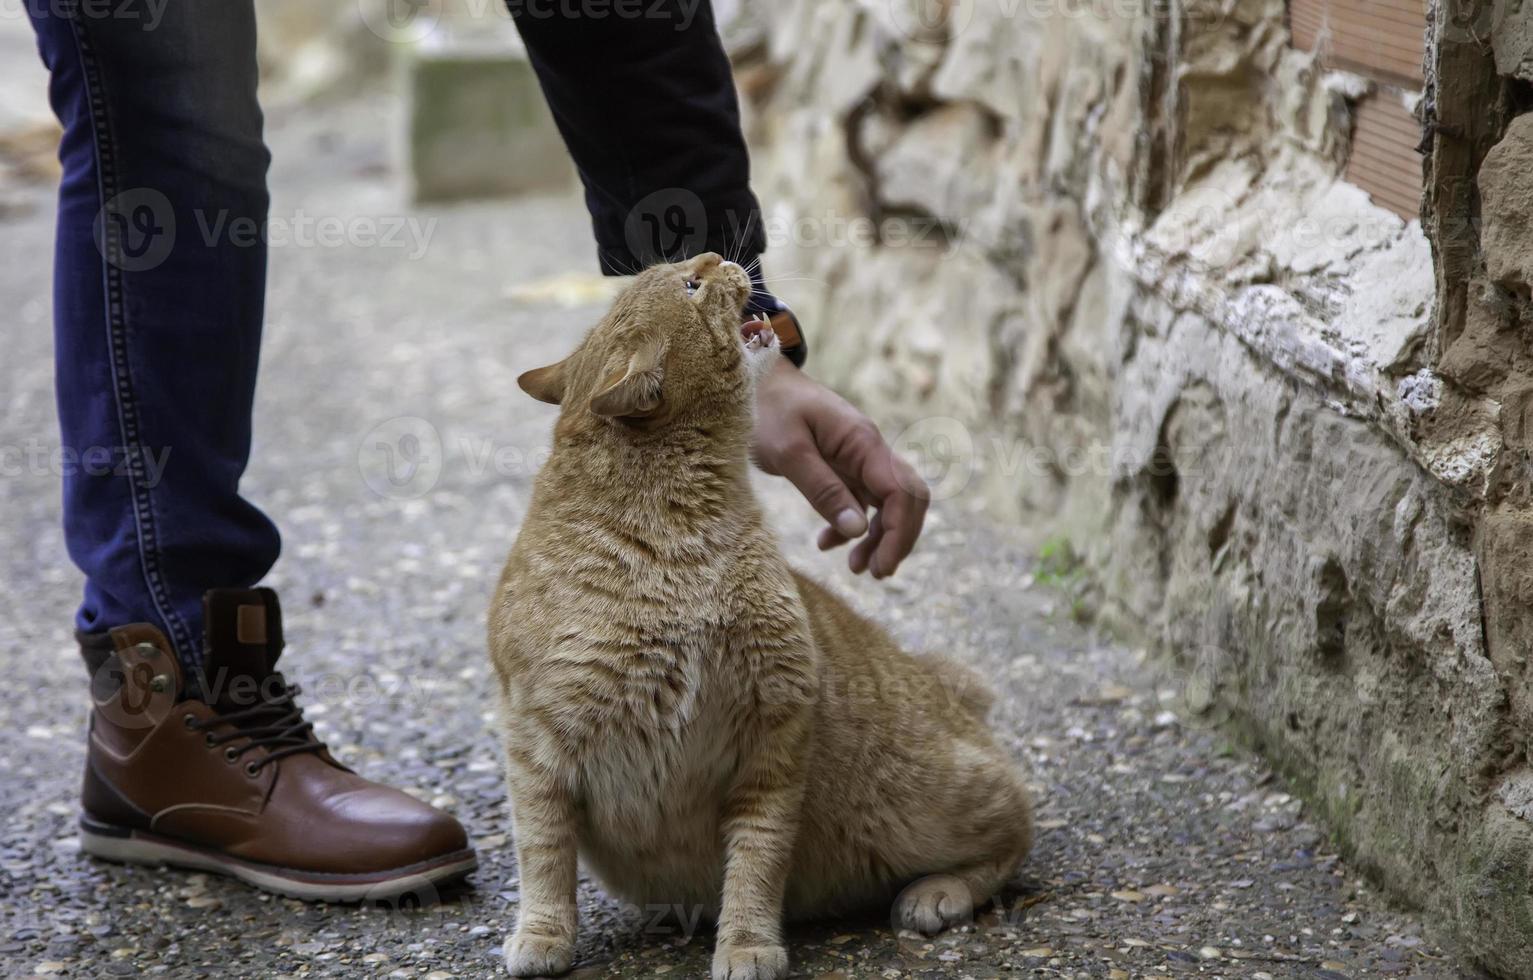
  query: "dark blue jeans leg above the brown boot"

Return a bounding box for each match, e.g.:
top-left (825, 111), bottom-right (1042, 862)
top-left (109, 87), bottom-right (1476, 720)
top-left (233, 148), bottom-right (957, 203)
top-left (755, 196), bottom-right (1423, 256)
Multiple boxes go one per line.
top-left (28, 0), bottom-right (279, 664)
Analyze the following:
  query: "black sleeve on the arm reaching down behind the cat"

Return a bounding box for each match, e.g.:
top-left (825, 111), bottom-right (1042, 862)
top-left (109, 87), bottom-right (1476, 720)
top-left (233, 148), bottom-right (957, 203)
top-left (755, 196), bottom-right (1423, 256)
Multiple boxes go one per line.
top-left (507, 0), bottom-right (765, 275)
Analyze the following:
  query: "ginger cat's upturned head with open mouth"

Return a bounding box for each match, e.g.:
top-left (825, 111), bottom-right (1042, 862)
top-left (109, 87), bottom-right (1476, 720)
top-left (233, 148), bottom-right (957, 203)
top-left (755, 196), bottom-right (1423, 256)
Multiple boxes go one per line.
top-left (517, 252), bottom-right (779, 432)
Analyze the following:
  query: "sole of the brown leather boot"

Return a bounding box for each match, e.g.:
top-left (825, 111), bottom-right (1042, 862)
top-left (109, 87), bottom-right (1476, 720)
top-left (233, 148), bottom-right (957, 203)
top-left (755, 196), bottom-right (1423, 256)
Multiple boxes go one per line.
top-left (80, 817), bottom-right (478, 908)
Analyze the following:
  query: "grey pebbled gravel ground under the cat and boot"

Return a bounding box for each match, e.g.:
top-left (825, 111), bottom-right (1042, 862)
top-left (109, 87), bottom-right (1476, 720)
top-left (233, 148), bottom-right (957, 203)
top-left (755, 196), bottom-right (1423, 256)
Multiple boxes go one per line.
top-left (0, 93), bottom-right (1478, 978)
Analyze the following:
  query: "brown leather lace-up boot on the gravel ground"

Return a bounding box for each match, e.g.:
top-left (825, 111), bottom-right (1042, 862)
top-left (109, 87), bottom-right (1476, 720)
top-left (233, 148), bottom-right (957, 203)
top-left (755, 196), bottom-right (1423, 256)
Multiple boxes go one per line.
top-left (80, 589), bottom-right (477, 902)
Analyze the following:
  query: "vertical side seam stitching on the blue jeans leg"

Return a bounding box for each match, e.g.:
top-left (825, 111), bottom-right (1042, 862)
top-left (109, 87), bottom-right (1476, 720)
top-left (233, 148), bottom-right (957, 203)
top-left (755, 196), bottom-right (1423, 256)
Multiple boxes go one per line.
top-left (63, 3), bottom-right (196, 666)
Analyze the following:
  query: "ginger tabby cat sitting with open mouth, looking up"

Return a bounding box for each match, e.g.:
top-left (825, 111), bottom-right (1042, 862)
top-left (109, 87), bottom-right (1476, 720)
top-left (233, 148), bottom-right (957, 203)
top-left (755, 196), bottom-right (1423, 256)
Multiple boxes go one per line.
top-left (489, 253), bottom-right (1032, 980)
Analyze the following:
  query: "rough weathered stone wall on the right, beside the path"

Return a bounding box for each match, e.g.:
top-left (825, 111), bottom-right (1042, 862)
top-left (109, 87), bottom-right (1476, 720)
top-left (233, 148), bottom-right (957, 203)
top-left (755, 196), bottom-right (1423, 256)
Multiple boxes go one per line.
top-left (740, 0), bottom-right (1533, 977)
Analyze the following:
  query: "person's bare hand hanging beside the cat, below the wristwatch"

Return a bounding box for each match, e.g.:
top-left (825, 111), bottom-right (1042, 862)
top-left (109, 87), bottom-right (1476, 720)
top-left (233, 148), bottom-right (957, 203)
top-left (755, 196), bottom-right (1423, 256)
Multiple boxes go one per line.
top-left (751, 360), bottom-right (931, 578)
